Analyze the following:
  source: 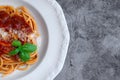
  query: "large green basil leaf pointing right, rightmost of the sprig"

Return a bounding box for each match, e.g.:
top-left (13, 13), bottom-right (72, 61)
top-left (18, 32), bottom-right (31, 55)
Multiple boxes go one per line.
top-left (21, 43), bottom-right (37, 53)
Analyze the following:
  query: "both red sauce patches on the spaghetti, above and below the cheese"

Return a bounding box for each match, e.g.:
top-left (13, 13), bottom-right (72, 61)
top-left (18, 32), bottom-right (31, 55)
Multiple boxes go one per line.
top-left (0, 11), bottom-right (32, 56)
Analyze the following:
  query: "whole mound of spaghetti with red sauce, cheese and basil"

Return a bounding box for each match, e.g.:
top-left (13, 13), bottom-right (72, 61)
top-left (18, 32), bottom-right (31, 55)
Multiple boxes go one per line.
top-left (0, 6), bottom-right (39, 77)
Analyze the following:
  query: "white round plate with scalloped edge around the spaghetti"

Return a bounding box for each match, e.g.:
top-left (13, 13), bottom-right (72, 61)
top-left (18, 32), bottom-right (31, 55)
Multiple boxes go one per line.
top-left (0, 0), bottom-right (70, 80)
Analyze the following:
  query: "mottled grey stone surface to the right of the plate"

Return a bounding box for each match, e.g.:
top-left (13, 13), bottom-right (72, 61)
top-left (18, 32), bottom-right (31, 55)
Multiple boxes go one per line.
top-left (55, 0), bottom-right (120, 80)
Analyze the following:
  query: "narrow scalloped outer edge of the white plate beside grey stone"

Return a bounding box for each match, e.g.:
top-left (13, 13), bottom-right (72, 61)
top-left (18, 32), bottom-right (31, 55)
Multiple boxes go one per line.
top-left (46, 0), bottom-right (70, 80)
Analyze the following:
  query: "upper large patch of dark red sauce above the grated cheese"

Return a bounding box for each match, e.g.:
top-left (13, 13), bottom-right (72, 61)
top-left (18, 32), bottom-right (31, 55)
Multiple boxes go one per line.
top-left (0, 11), bottom-right (32, 34)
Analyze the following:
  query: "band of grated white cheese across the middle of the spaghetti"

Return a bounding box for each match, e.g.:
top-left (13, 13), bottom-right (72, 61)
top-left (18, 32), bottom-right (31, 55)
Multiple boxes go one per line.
top-left (0, 28), bottom-right (36, 42)
